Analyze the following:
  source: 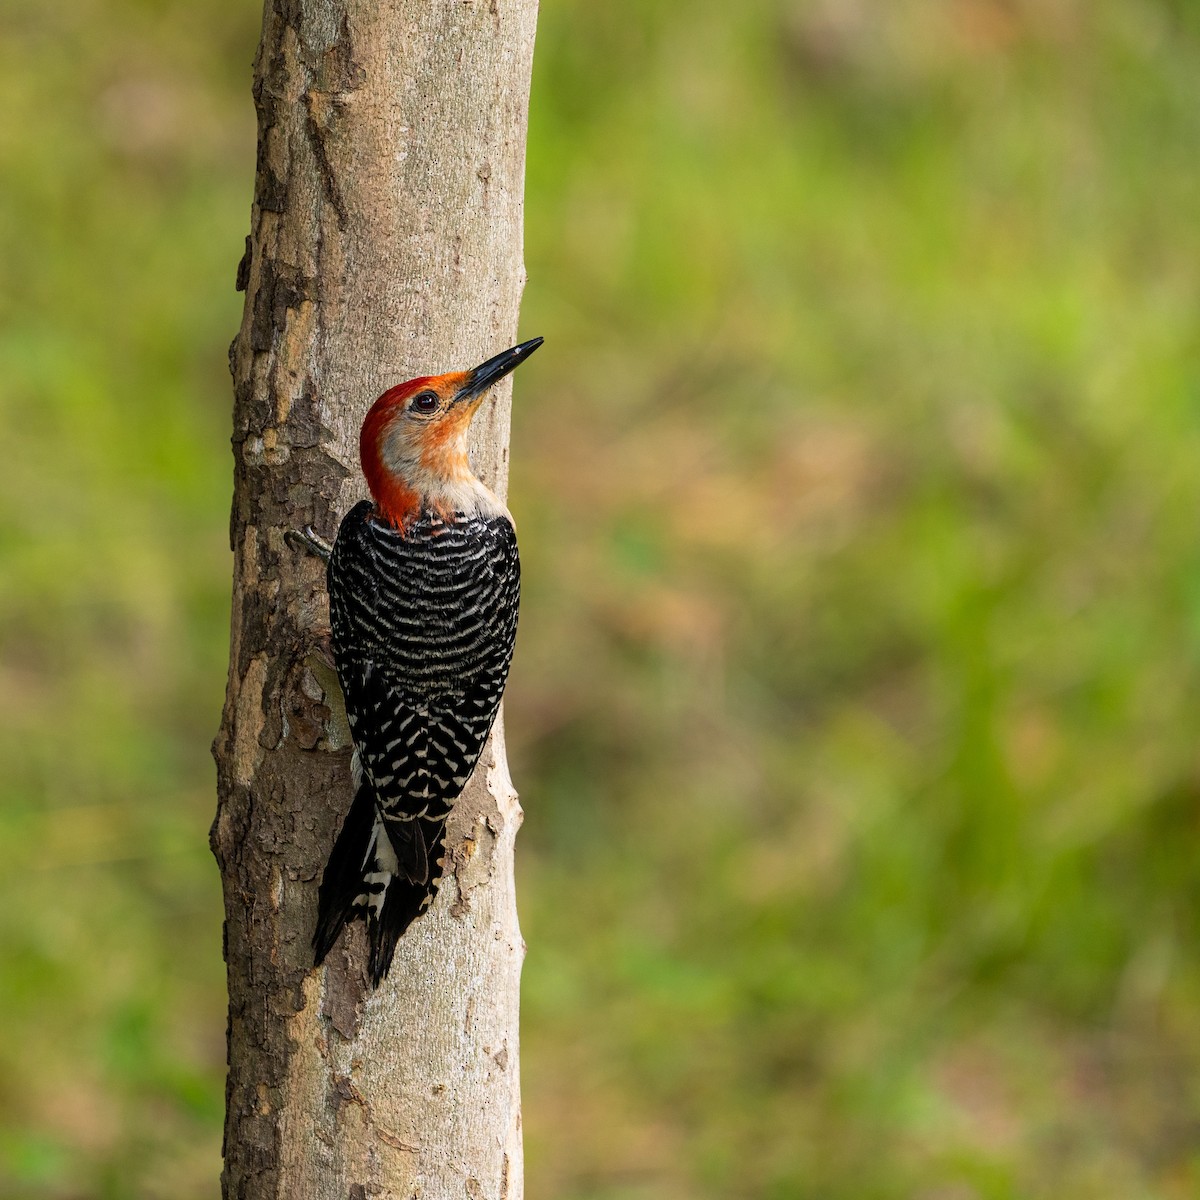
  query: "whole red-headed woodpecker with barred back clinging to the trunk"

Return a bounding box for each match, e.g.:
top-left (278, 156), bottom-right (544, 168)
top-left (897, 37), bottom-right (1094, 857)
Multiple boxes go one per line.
top-left (301, 337), bottom-right (542, 986)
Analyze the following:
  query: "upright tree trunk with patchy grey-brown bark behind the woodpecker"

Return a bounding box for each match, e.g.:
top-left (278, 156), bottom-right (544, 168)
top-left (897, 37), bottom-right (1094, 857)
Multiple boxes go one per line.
top-left (212, 0), bottom-right (536, 1200)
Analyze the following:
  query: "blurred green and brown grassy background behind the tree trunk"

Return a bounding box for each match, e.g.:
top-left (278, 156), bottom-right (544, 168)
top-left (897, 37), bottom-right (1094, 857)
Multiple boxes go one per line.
top-left (0, 0), bottom-right (1200, 1200)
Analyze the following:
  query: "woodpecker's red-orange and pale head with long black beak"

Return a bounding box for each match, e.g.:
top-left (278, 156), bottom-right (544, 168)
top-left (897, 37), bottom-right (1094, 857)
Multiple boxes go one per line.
top-left (359, 337), bottom-right (541, 529)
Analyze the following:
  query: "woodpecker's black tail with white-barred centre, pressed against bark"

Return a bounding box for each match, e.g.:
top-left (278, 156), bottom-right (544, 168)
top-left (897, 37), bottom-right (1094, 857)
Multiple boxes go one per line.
top-left (312, 778), bottom-right (445, 988)
